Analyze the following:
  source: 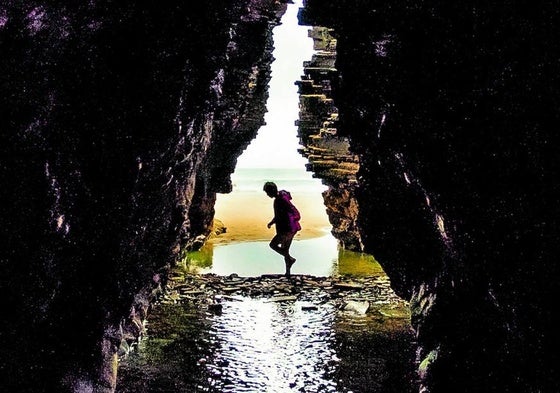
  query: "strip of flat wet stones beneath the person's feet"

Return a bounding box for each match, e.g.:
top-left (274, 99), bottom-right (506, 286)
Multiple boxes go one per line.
top-left (160, 271), bottom-right (409, 316)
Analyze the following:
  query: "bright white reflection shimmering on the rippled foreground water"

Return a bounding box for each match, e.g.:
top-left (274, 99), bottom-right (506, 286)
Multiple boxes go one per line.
top-left (205, 299), bottom-right (337, 392)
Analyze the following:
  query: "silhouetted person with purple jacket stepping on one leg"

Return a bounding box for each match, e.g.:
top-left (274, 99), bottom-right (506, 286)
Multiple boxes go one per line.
top-left (263, 182), bottom-right (301, 277)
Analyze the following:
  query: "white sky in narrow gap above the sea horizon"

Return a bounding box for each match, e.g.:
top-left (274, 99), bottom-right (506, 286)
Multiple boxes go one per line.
top-left (237, 0), bottom-right (313, 168)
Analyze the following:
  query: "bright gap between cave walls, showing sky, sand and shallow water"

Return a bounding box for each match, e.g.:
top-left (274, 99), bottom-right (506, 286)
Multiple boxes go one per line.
top-left (198, 0), bottom-right (338, 276)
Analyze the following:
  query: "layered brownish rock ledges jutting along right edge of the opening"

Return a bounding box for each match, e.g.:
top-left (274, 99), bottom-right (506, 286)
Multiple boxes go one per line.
top-left (296, 26), bottom-right (362, 251)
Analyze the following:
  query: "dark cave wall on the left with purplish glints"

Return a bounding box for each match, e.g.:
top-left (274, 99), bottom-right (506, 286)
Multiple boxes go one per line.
top-left (0, 0), bottom-right (285, 392)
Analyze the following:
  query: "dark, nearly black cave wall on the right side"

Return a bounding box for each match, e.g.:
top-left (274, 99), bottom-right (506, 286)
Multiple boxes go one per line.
top-left (302, 0), bottom-right (560, 392)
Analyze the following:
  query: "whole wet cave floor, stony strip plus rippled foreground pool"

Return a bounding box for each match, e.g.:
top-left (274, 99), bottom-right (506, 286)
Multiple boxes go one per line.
top-left (117, 269), bottom-right (417, 393)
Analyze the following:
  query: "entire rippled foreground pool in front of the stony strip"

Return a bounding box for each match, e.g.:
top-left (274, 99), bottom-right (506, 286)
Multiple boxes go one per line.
top-left (117, 298), bottom-right (414, 393)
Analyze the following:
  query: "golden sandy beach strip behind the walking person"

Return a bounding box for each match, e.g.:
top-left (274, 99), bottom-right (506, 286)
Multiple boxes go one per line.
top-left (211, 191), bottom-right (331, 244)
